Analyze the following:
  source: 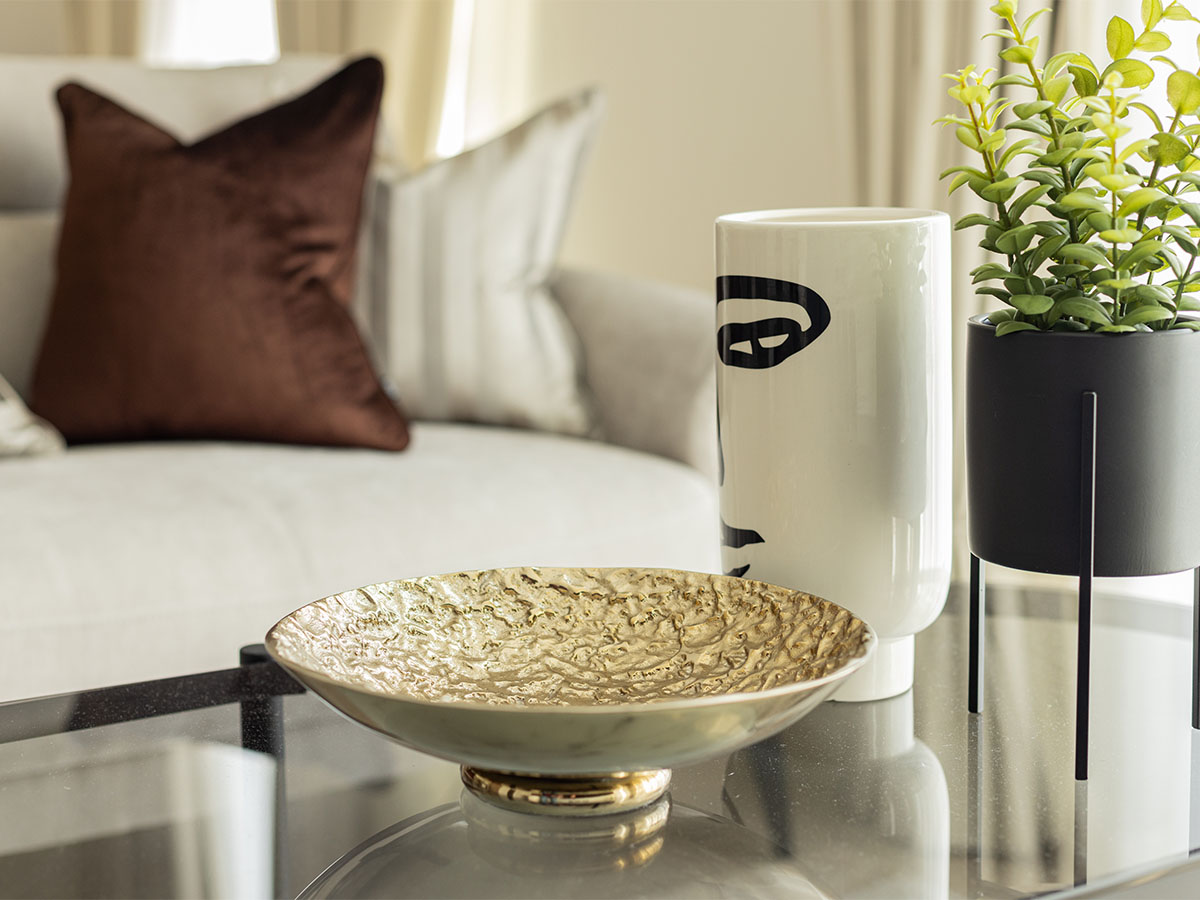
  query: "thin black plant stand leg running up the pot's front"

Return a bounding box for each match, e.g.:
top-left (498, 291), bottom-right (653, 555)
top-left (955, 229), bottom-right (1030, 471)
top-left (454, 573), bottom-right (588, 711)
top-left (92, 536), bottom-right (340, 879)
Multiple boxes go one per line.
top-left (1075, 391), bottom-right (1098, 781)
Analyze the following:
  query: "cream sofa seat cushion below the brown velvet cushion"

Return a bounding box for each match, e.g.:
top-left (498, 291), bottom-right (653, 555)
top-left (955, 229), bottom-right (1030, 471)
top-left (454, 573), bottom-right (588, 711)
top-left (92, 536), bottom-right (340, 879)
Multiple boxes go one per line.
top-left (0, 422), bottom-right (720, 700)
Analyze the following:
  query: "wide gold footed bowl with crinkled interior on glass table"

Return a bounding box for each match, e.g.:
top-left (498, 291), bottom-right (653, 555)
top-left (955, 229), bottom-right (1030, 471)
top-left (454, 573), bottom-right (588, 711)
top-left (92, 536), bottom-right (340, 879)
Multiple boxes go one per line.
top-left (266, 568), bottom-right (876, 814)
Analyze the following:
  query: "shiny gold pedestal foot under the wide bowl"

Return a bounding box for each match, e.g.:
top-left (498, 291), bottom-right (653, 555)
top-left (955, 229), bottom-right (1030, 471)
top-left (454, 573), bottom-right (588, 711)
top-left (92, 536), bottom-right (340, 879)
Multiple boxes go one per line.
top-left (462, 766), bottom-right (671, 816)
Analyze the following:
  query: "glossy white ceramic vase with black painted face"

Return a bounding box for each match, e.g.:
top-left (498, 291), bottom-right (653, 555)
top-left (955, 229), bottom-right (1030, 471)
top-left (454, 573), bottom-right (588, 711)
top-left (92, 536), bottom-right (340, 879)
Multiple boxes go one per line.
top-left (716, 208), bottom-right (952, 700)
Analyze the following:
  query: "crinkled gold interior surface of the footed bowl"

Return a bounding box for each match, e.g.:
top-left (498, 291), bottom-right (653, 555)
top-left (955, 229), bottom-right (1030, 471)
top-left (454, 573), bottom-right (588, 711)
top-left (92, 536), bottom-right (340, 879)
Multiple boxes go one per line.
top-left (268, 568), bottom-right (872, 707)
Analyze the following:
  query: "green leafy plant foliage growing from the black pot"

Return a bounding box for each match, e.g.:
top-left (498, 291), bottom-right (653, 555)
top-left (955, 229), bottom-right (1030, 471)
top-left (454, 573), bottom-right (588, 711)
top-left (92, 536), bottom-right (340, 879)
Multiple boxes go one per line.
top-left (938, 0), bottom-right (1200, 336)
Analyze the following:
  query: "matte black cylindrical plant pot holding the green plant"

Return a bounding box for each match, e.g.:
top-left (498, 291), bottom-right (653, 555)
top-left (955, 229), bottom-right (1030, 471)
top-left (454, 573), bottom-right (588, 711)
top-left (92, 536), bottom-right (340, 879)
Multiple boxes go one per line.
top-left (966, 316), bottom-right (1200, 576)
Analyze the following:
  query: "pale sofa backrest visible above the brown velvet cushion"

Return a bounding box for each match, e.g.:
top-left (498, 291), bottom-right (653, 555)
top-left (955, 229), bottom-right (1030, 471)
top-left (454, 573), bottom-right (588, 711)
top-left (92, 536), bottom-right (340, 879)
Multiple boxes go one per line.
top-left (0, 55), bottom-right (355, 209)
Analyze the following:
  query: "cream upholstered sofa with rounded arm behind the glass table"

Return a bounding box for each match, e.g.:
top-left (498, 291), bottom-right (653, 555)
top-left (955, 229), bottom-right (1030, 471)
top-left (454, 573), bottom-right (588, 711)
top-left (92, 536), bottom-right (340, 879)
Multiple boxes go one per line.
top-left (0, 56), bottom-right (719, 701)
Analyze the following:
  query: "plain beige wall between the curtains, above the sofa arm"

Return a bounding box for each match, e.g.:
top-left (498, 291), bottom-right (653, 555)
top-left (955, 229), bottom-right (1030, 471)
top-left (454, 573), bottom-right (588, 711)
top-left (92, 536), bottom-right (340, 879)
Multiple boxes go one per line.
top-left (520, 0), bottom-right (859, 289)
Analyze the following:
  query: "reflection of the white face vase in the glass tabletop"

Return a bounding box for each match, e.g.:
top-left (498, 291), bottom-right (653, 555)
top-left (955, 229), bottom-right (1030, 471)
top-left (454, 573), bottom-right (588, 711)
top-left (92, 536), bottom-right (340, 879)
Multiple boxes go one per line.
top-left (725, 691), bottom-right (950, 900)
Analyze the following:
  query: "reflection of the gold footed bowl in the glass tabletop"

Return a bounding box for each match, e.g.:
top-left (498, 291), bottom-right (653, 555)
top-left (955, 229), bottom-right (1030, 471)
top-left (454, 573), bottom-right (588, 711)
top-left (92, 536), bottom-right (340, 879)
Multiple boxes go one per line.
top-left (300, 791), bottom-right (826, 900)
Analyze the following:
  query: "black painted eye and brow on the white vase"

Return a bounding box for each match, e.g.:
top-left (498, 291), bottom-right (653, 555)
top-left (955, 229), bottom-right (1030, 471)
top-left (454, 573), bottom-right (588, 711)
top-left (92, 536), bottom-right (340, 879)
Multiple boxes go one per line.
top-left (716, 275), bottom-right (829, 368)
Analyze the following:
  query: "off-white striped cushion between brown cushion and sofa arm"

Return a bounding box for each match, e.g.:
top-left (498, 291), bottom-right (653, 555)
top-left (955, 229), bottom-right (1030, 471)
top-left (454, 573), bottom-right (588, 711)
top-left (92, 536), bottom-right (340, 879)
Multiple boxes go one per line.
top-left (367, 91), bottom-right (601, 434)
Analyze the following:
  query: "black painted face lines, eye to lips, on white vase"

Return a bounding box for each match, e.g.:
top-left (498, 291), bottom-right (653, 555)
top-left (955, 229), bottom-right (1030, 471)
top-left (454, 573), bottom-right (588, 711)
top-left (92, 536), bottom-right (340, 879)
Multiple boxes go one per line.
top-left (716, 275), bottom-right (830, 577)
